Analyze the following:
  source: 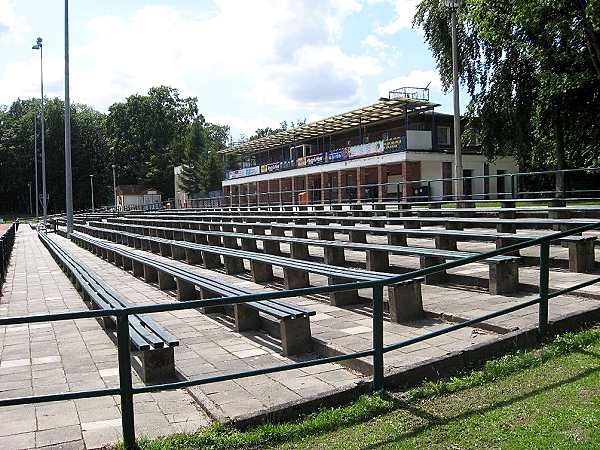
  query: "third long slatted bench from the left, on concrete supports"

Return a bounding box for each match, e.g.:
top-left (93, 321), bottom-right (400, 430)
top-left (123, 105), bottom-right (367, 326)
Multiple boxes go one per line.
top-left (70, 226), bottom-right (424, 322)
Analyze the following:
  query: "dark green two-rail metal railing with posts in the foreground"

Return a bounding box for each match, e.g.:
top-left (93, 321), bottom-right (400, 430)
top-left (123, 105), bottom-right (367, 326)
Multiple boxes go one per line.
top-left (0, 222), bottom-right (600, 448)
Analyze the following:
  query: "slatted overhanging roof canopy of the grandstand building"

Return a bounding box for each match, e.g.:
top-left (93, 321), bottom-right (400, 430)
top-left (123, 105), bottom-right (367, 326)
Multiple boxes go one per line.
top-left (220, 97), bottom-right (440, 154)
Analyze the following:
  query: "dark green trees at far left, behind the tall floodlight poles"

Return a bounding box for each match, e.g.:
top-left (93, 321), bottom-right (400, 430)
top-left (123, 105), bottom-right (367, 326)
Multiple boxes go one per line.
top-left (0, 98), bottom-right (112, 214)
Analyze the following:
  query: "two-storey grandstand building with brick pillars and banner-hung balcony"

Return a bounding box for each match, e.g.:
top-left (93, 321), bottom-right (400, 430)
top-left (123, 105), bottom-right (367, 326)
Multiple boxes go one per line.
top-left (222, 88), bottom-right (517, 205)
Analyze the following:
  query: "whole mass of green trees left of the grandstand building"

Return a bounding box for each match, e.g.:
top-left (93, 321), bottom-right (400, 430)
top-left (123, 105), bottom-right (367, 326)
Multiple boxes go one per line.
top-left (0, 86), bottom-right (229, 213)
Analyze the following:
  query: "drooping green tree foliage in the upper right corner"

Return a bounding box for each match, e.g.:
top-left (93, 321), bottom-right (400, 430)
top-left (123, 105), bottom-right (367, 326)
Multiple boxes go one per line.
top-left (415, 0), bottom-right (600, 169)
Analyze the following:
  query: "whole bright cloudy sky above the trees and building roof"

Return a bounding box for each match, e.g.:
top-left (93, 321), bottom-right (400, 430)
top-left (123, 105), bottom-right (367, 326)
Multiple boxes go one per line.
top-left (0, 0), bottom-right (466, 140)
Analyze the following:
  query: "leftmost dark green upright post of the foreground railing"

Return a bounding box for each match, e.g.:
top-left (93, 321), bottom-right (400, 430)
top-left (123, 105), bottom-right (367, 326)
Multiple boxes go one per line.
top-left (117, 314), bottom-right (136, 449)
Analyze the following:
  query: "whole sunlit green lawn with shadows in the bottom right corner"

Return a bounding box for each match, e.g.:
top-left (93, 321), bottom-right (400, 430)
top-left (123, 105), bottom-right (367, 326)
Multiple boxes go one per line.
top-left (125, 327), bottom-right (600, 450)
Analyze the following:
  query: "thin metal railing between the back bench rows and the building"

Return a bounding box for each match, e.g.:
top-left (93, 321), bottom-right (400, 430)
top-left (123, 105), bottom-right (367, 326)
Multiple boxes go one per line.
top-left (207, 167), bottom-right (600, 208)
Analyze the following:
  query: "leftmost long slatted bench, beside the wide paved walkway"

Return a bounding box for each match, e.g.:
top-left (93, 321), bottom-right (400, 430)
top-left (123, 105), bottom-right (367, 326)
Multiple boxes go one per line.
top-left (38, 233), bottom-right (179, 383)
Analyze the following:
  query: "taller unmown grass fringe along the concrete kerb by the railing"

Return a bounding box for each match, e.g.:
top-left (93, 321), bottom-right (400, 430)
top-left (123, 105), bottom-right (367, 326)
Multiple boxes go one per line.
top-left (123, 327), bottom-right (600, 450)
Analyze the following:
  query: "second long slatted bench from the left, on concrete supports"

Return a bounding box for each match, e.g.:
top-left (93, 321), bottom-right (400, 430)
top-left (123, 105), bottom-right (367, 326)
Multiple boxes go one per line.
top-left (71, 232), bottom-right (316, 356)
